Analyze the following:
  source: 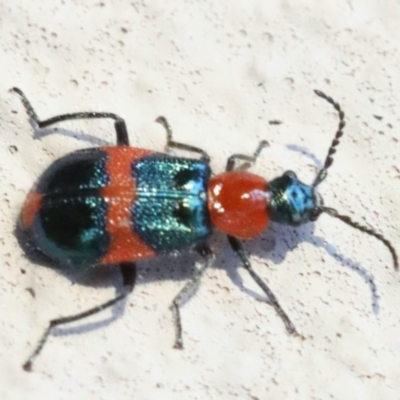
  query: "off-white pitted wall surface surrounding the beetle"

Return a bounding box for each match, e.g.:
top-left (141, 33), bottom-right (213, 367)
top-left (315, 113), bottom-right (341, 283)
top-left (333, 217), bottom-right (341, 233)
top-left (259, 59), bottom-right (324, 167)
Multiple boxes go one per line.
top-left (0, 0), bottom-right (400, 400)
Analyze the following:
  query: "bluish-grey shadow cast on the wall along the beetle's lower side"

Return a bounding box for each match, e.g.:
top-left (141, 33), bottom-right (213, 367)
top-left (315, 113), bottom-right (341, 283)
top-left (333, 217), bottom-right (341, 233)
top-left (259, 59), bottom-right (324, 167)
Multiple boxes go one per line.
top-left (16, 217), bottom-right (379, 346)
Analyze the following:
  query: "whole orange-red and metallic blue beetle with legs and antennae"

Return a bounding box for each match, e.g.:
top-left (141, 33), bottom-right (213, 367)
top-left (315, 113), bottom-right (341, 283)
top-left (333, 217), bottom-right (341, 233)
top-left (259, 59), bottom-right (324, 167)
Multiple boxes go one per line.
top-left (11, 88), bottom-right (398, 371)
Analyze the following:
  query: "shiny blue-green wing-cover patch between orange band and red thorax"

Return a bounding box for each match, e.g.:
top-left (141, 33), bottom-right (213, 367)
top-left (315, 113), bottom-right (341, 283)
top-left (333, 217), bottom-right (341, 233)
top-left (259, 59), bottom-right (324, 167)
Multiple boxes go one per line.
top-left (132, 154), bottom-right (211, 252)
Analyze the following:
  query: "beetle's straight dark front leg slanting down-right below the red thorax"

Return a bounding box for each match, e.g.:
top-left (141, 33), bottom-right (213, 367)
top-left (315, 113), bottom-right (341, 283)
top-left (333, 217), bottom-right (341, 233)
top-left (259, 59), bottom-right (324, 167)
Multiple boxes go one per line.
top-left (228, 236), bottom-right (299, 336)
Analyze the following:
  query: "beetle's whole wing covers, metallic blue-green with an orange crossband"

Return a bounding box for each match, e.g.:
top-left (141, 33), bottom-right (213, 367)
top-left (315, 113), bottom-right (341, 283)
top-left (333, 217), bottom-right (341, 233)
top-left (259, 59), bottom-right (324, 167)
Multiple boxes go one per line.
top-left (22, 148), bottom-right (211, 266)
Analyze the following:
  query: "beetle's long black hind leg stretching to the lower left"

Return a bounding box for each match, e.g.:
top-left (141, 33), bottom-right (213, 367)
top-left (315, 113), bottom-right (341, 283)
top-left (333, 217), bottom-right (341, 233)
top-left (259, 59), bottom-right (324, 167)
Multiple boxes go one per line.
top-left (23, 262), bottom-right (136, 372)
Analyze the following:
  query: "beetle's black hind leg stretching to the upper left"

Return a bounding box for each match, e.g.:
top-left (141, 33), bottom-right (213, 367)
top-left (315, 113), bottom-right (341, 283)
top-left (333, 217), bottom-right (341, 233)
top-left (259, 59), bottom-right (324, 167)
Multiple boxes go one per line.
top-left (10, 87), bottom-right (129, 146)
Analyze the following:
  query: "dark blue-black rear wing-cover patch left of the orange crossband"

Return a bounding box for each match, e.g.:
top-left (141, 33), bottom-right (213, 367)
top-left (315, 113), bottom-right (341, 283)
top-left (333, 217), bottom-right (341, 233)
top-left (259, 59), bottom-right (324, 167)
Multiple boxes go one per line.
top-left (29, 148), bottom-right (110, 265)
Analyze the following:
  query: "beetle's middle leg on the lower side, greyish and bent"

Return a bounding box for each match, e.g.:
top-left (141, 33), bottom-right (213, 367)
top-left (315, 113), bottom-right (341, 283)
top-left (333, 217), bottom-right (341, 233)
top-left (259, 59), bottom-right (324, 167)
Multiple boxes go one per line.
top-left (171, 246), bottom-right (214, 349)
